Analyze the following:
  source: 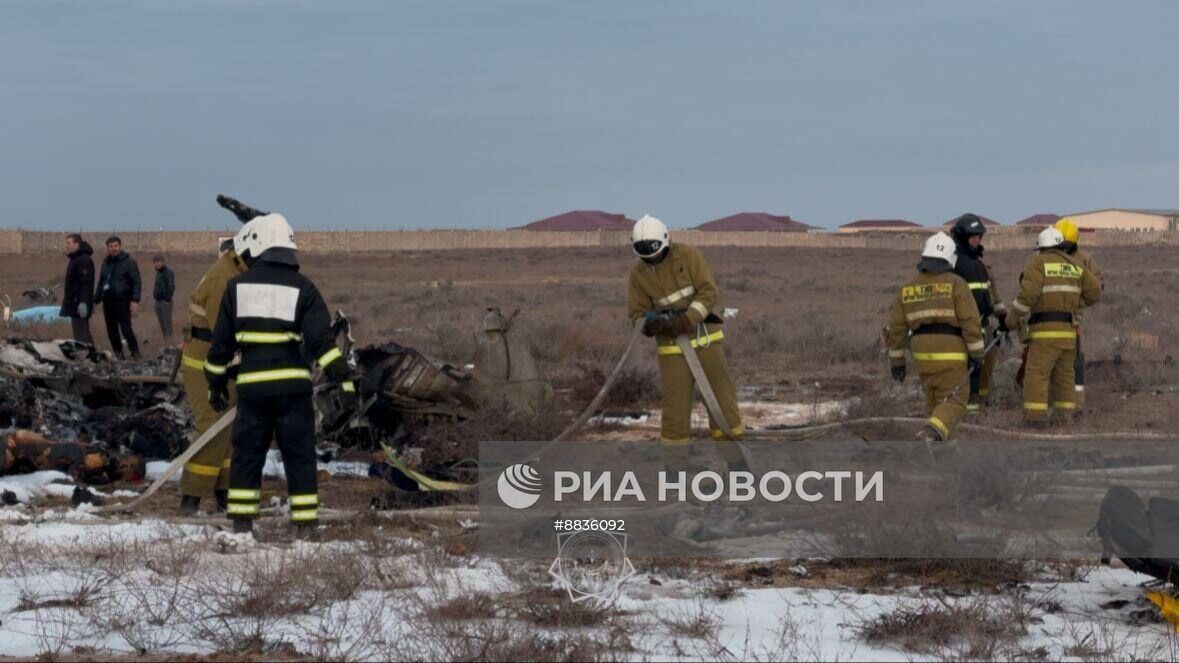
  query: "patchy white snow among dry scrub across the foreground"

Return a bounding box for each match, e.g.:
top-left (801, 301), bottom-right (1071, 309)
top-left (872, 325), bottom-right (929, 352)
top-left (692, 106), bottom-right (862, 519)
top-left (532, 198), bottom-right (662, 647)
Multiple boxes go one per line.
top-left (0, 500), bottom-right (1174, 661)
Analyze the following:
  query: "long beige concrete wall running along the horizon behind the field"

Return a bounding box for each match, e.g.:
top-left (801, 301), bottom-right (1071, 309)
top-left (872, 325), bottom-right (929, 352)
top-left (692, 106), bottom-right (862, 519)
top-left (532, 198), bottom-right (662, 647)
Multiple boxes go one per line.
top-left (0, 228), bottom-right (1179, 255)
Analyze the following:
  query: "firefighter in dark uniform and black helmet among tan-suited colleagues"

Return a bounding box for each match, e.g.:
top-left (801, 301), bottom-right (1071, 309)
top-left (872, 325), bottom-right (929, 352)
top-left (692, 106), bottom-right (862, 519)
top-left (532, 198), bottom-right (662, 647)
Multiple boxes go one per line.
top-left (950, 214), bottom-right (1007, 413)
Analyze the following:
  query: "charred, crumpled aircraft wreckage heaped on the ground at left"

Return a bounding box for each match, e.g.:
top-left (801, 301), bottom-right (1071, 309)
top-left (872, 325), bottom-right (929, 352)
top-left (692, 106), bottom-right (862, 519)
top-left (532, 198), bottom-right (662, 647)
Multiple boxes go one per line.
top-left (0, 308), bottom-right (552, 500)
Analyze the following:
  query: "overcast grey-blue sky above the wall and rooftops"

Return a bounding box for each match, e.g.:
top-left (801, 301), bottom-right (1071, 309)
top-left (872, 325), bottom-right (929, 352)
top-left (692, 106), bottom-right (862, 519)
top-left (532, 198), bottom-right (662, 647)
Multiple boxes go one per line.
top-left (0, 0), bottom-right (1179, 229)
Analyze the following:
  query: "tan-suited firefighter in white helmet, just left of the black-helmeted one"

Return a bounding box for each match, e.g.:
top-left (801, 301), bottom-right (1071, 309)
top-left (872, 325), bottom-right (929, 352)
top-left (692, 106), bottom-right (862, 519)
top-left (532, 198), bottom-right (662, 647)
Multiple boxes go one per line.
top-left (888, 232), bottom-right (986, 442)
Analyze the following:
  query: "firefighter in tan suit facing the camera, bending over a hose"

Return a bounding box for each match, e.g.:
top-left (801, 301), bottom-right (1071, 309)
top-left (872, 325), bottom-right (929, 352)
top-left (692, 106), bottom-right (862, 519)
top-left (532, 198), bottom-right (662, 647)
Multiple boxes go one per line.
top-left (626, 216), bottom-right (749, 471)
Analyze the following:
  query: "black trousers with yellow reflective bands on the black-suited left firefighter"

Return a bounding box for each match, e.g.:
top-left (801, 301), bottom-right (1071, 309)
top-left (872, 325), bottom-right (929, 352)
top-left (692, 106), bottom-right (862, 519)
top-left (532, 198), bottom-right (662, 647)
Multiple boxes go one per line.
top-left (228, 395), bottom-right (320, 525)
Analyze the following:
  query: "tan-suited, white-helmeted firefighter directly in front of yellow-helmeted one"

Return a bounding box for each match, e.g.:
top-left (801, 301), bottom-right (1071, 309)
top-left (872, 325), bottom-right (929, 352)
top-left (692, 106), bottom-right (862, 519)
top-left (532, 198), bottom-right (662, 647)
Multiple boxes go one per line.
top-left (1007, 228), bottom-right (1101, 427)
